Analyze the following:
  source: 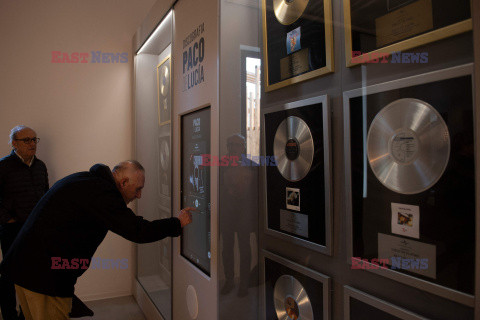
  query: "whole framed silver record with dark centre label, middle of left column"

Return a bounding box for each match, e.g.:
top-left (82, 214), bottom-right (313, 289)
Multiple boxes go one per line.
top-left (264, 95), bottom-right (332, 255)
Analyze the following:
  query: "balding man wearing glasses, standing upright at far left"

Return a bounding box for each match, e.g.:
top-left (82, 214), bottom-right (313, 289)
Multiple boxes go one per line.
top-left (0, 126), bottom-right (48, 320)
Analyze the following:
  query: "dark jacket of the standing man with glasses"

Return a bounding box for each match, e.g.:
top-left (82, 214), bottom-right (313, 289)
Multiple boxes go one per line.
top-left (0, 151), bottom-right (48, 224)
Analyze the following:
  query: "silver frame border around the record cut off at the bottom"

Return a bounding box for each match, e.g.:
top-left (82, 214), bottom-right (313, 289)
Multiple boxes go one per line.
top-left (259, 250), bottom-right (332, 320)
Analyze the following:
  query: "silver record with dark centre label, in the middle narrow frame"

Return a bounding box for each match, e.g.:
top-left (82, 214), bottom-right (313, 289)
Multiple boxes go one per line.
top-left (273, 116), bottom-right (314, 182)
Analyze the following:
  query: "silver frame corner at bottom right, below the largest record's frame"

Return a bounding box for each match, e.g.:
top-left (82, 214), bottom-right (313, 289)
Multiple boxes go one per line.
top-left (343, 286), bottom-right (428, 320)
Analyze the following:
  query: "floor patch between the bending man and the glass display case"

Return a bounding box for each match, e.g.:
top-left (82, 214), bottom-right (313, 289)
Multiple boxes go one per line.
top-left (72, 296), bottom-right (145, 320)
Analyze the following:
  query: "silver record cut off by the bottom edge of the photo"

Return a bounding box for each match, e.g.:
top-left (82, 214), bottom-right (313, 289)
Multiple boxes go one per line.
top-left (273, 275), bottom-right (313, 320)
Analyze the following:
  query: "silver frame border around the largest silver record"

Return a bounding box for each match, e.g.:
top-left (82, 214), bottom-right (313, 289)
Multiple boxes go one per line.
top-left (343, 63), bottom-right (479, 307)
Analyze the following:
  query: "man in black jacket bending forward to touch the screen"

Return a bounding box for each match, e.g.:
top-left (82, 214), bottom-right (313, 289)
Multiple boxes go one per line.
top-left (0, 161), bottom-right (194, 320)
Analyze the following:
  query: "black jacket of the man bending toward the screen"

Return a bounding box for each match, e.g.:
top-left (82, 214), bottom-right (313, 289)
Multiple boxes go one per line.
top-left (0, 164), bottom-right (181, 297)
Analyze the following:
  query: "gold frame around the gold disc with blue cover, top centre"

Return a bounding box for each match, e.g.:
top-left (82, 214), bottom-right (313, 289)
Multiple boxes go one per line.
top-left (262, 0), bottom-right (334, 92)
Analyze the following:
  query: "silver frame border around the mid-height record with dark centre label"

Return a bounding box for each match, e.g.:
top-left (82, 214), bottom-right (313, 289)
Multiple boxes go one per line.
top-left (262, 95), bottom-right (333, 256)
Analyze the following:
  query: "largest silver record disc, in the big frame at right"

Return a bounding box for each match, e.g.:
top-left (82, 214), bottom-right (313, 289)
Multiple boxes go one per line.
top-left (367, 98), bottom-right (450, 194)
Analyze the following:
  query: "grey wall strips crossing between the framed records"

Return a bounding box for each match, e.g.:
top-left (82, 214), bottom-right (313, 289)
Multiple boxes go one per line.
top-left (259, 1), bottom-right (473, 319)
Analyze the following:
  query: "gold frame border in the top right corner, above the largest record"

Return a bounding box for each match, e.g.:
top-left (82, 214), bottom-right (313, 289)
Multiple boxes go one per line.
top-left (343, 0), bottom-right (472, 67)
